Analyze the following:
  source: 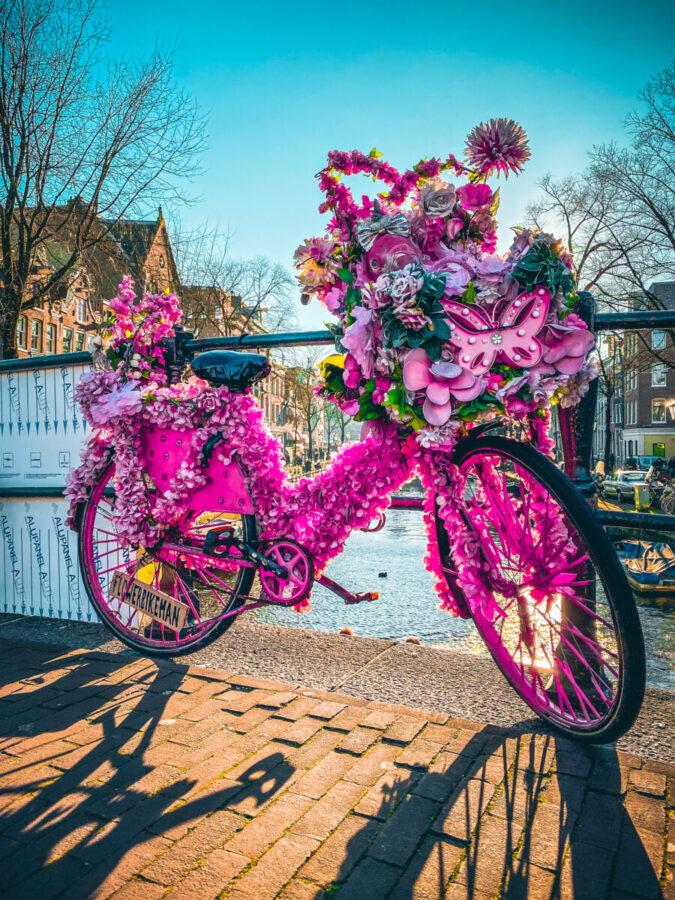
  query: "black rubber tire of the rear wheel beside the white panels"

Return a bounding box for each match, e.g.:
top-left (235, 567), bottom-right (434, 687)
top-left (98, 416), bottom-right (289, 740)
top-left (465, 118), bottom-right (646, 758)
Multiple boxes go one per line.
top-left (78, 463), bottom-right (256, 658)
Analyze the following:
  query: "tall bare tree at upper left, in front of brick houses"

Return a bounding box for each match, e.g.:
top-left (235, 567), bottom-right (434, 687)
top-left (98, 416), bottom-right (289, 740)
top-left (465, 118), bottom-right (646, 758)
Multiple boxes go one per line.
top-left (0, 0), bottom-right (204, 358)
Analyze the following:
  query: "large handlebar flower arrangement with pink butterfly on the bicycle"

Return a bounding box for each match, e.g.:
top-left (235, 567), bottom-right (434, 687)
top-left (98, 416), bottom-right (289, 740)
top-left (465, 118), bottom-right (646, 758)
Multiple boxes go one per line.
top-left (295, 119), bottom-right (597, 445)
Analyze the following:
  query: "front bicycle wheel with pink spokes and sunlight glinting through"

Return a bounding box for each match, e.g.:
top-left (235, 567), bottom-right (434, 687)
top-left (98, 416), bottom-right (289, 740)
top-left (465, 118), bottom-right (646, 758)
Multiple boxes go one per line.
top-left (437, 435), bottom-right (645, 743)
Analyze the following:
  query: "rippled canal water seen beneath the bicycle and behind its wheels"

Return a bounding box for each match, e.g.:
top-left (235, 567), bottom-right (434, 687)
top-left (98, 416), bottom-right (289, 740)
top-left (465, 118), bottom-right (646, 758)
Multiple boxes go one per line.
top-left (256, 510), bottom-right (675, 690)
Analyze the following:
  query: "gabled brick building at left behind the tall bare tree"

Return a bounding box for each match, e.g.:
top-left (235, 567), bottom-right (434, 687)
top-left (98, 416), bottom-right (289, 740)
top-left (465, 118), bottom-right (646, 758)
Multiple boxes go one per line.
top-left (17, 208), bottom-right (178, 357)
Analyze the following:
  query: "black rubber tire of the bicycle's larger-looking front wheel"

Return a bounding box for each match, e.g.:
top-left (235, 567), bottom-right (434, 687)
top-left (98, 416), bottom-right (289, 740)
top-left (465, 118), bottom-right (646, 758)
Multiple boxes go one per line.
top-left (436, 435), bottom-right (646, 743)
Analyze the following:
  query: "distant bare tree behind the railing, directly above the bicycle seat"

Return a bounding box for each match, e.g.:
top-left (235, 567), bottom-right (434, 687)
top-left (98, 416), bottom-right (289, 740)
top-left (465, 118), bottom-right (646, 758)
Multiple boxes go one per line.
top-left (173, 225), bottom-right (295, 335)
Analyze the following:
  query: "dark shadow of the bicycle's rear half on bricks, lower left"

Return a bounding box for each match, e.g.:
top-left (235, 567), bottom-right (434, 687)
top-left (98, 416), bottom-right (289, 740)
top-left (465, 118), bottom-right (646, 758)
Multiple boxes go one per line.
top-left (0, 652), bottom-right (295, 900)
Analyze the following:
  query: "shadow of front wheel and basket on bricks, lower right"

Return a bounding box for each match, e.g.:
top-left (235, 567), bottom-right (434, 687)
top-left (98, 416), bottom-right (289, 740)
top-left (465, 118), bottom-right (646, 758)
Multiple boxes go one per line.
top-left (332, 729), bottom-right (663, 900)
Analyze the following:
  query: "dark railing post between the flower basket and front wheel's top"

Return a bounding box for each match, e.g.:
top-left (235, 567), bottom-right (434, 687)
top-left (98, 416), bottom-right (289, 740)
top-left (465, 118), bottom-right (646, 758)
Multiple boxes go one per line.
top-left (558, 291), bottom-right (598, 500)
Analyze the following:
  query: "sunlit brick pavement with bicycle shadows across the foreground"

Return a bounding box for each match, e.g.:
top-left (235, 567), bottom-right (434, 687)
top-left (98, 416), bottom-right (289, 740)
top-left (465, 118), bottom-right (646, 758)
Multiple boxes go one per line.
top-left (0, 641), bottom-right (675, 900)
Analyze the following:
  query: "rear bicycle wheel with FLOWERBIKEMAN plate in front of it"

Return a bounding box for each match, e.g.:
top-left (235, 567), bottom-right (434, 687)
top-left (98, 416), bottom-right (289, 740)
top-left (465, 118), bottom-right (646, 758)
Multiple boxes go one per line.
top-left (79, 464), bottom-right (256, 657)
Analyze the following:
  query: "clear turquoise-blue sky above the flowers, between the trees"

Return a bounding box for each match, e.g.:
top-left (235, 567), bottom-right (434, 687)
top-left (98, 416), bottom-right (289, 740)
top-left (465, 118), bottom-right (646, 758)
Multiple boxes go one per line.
top-left (109, 0), bottom-right (675, 318)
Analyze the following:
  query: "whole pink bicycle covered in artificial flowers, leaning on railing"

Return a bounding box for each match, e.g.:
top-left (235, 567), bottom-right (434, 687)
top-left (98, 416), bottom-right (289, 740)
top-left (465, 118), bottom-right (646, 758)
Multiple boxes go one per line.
top-left (67, 126), bottom-right (645, 742)
